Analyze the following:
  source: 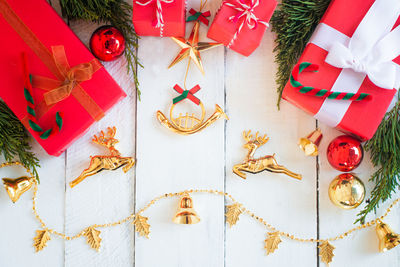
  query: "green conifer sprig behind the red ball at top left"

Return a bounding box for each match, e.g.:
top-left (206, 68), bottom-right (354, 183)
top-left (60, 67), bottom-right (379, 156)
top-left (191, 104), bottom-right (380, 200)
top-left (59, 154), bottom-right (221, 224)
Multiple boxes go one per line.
top-left (60, 0), bottom-right (143, 99)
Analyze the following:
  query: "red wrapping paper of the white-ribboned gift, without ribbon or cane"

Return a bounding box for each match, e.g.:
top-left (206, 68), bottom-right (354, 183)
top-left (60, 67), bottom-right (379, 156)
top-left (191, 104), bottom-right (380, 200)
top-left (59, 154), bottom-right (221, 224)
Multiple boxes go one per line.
top-left (282, 0), bottom-right (400, 140)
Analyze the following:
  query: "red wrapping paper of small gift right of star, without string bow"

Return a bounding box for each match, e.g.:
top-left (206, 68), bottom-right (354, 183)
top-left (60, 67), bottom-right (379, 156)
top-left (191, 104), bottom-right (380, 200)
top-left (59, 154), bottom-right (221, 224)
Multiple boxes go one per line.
top-left (207, 0), bottom-right (277, 57)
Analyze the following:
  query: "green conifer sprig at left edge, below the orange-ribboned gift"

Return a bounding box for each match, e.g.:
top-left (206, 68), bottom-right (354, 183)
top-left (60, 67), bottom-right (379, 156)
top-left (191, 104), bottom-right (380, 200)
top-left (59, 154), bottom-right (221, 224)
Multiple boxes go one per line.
top-left (0, 101), bottom-right (39, 179)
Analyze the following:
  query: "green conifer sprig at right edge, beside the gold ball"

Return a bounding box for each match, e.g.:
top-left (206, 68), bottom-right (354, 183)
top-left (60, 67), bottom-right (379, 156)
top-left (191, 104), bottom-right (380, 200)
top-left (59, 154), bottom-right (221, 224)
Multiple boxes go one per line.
top-left (356, 99), bottom-right (400, 224)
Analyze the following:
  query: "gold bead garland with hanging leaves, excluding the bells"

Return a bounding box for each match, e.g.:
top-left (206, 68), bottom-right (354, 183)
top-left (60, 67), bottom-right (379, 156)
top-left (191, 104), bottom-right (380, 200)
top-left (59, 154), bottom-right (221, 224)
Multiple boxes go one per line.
top-left (0, 162), bottom-right (400, 265)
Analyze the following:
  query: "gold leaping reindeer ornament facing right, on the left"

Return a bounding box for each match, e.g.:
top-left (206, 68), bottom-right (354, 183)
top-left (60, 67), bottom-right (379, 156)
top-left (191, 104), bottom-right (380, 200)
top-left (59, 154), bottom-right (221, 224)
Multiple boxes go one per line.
top-left (69, 127), bottom-right (135, 188)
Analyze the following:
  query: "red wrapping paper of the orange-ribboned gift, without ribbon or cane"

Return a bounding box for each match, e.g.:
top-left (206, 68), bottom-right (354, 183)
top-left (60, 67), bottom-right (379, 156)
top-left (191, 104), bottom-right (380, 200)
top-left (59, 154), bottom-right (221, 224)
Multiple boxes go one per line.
top-left (0, 0), bottom-right (126, 156)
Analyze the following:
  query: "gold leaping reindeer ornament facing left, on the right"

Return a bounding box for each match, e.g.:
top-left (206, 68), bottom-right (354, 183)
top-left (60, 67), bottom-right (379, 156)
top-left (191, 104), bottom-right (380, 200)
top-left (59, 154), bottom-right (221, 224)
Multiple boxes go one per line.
top-left (233, 131), bottom-right (302, 180)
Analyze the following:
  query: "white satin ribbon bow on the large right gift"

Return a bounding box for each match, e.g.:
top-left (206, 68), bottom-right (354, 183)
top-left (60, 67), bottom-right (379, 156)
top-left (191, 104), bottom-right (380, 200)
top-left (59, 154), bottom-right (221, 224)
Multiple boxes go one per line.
top-left (325, 0), bottom-right (400, 89)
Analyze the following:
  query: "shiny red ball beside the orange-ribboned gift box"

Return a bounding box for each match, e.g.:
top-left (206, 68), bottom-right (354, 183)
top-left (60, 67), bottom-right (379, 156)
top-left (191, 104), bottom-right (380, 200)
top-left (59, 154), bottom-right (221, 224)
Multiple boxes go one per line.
top-left (90, 26), bottom-right (125, 61)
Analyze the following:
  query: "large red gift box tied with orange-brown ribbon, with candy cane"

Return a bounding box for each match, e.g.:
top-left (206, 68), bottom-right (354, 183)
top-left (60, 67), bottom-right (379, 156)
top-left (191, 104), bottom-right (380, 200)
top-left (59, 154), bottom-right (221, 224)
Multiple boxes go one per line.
top-left (0, 0), bottom-right (126, 156)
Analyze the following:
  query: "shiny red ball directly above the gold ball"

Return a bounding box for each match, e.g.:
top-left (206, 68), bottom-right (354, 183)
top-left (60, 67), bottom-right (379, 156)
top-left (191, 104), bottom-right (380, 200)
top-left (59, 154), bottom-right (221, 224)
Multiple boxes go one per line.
top-left (327, 135), bottom-right (364, 172)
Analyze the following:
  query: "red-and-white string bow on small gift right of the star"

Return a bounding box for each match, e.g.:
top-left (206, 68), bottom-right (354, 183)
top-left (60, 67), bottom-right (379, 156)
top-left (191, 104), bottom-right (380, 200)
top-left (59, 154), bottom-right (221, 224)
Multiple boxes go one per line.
top-left (224, 0), bottom-right (269, 48)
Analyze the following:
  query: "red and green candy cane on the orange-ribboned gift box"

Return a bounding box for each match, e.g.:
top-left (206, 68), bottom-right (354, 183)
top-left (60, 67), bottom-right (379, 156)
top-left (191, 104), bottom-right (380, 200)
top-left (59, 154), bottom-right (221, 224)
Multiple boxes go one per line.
top-left (22, 53), bottom-right (63, 139)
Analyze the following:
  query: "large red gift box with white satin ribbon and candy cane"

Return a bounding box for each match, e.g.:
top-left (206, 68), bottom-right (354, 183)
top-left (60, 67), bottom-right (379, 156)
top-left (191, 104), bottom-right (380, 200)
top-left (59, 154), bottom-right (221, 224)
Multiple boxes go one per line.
top-left (282, 0), bottom-right (400, 140)
